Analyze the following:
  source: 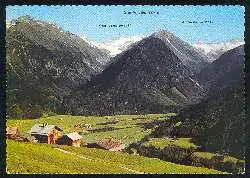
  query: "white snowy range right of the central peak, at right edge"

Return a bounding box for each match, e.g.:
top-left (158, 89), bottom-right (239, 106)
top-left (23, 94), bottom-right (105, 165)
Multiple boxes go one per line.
top-left (193, 40), bottom-right (244, 62)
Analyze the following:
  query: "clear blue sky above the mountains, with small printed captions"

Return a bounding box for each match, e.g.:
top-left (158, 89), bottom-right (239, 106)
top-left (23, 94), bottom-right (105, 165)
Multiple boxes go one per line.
top-left (6, 6), bottom-right (245, 43)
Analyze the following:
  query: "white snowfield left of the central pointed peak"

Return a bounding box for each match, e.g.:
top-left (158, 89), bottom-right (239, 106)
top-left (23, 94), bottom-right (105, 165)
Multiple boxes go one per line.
top-left (83, 36), bottom-right (144, 57)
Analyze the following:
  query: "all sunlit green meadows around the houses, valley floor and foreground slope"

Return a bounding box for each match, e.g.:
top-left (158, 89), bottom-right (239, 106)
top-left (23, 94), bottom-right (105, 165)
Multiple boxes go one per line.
top-left (6, 113), bottom-right (241, 174)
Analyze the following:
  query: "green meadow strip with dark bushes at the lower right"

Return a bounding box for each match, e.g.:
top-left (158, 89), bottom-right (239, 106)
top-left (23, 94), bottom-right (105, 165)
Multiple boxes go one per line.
top-left (135, 137), bottom-right (245, 174)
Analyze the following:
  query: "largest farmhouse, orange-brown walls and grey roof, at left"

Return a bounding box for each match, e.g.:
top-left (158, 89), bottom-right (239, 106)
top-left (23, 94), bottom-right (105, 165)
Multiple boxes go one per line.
top-left (28, 123), bottom-right (62, 144)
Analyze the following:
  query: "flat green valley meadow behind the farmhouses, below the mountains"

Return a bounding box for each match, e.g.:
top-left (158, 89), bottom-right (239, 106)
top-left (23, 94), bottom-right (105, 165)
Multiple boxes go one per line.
top-left (7, 113), bottom-right (175, 145)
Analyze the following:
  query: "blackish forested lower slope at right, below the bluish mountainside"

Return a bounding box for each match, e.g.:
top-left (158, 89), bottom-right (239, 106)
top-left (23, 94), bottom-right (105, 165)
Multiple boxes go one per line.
top-left (174, 82), bottom-right (245, 159)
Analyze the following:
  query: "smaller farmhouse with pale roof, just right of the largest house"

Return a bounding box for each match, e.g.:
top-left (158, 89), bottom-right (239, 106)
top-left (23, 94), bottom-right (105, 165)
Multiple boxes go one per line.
top-left (57, 132), bottom-right (82, 147)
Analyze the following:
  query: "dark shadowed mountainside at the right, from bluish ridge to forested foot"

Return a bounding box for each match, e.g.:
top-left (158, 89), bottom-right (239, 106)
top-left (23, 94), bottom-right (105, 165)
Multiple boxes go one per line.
top-left (159, 45), bottom-right (245, 159)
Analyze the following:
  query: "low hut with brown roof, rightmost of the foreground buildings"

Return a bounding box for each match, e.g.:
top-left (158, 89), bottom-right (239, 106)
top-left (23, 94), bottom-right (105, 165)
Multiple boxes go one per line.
top-left (97, 138), bottom-right (125, 151)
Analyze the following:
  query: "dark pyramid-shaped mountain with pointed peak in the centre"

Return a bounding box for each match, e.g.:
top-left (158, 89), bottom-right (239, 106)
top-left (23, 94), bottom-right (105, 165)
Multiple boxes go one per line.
top-left (64, 31), bottom-right (208, 114)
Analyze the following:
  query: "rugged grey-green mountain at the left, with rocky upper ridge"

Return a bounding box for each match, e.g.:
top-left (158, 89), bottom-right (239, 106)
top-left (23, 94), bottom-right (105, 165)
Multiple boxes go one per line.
top-left (6, 16), bottom-right (109, 117)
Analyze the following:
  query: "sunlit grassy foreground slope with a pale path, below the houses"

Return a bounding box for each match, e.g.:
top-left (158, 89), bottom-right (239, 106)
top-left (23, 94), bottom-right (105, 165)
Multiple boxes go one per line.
top-left (7, 141), bottom-right (226, 174)
